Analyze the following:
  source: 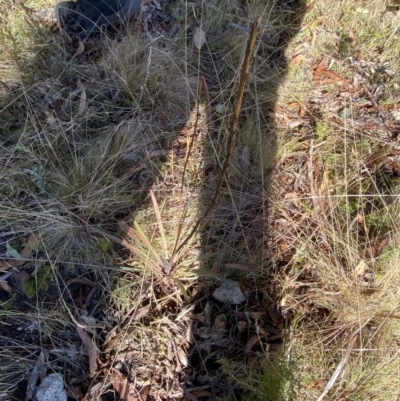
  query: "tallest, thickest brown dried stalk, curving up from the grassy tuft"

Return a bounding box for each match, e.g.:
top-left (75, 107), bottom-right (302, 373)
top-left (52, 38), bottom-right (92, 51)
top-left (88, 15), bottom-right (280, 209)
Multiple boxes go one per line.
top-left (170, 17), bottom-right (261, 271)
